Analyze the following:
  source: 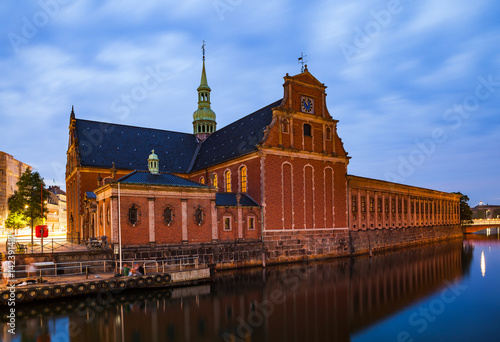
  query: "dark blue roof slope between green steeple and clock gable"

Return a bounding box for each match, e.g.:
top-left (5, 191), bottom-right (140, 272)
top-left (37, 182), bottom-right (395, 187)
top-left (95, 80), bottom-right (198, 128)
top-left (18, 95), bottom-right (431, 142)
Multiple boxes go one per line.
top-left (189, 100), bottom-right (282, 171)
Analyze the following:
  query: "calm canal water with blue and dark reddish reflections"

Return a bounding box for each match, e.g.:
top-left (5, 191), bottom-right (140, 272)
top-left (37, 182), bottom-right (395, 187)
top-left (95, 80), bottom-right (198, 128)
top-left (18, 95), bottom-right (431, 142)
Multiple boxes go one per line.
top-left (0, 231), bottom-right (500, 342)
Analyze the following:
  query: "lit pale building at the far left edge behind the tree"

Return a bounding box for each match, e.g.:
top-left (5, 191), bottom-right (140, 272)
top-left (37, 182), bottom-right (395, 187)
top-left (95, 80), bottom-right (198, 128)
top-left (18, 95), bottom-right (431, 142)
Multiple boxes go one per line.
top-left (0, 151), bottom-right (30, 227)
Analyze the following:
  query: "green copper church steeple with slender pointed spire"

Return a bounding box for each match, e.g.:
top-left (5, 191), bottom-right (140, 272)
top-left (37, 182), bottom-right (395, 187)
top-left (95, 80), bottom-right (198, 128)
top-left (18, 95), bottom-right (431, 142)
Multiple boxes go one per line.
top-left (193, 41), bottom-right (217, 140)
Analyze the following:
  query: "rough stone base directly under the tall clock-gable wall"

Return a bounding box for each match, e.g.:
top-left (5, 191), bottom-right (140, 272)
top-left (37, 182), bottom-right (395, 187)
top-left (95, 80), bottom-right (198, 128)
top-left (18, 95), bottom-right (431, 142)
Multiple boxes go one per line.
top-left (264, 229), bottom-right (349, 264)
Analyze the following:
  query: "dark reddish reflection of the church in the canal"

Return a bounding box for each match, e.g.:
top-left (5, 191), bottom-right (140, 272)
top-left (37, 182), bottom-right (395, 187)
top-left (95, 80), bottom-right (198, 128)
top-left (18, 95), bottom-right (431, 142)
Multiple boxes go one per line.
top-left (5, 240), bottom-right (472, 342)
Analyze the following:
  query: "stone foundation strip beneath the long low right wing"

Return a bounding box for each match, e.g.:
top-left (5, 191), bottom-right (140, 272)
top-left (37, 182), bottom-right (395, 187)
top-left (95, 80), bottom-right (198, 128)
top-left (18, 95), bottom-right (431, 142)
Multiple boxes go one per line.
top-left (349, 225), bottom-right (463, 255)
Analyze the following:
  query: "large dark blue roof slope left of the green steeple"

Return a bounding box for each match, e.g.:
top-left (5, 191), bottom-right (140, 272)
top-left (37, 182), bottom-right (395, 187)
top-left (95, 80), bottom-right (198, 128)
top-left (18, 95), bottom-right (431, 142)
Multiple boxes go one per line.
top-left (76, 119), bottom-right (198, 173)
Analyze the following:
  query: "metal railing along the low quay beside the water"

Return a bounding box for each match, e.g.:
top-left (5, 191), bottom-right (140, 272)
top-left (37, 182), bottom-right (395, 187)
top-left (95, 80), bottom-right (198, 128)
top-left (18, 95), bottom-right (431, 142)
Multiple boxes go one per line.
top-left (0, 257), bottom-right (203, 281)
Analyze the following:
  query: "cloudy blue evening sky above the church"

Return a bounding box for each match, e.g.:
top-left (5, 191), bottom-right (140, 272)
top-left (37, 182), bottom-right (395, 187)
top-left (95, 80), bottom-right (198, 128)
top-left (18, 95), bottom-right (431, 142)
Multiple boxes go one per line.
top-left (0, 0), bottom-right (500, 206)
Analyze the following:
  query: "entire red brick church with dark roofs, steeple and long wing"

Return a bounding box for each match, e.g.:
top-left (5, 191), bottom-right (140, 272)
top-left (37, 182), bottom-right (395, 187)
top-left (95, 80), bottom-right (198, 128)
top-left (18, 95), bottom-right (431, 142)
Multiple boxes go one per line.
top-left (66, 49), bottom-right (460, 262)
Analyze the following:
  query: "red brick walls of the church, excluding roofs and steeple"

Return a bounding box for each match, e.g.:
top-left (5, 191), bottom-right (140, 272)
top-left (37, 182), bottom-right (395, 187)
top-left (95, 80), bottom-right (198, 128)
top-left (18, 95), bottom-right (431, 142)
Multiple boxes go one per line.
top-left (66, 69), bottom-right (459, 260)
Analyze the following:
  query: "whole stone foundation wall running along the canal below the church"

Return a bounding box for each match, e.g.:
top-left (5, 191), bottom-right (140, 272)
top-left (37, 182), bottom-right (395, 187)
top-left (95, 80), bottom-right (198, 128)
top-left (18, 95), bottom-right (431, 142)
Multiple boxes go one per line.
top-left (16, 225), bottom-right (463, 269)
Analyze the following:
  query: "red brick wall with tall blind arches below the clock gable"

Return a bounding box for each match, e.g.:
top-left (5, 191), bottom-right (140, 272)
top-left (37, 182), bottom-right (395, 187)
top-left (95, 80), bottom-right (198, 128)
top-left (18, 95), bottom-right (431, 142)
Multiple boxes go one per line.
top-left (264, 155), bottom-right (347, 230)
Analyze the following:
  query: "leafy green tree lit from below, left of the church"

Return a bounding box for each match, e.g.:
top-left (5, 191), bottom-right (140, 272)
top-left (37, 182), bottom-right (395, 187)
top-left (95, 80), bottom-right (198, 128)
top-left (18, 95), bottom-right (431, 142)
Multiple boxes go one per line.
top-left (9, 168), bottom-right (49, 243)
